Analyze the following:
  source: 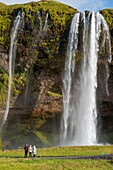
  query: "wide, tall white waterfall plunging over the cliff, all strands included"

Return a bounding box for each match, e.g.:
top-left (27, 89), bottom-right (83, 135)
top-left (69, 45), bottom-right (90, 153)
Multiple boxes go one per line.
top-left (61, 12), bottom-right (111, 145)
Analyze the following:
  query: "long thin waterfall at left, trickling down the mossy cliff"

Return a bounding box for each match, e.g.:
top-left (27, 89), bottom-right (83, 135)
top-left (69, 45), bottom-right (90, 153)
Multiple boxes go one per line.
top-left (0, 11), bottom-right (24, 131)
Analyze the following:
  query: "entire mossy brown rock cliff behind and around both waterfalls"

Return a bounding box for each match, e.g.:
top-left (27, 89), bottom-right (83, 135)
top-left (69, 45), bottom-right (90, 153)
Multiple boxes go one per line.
top-left (0, 1), bottom-right (113, 147)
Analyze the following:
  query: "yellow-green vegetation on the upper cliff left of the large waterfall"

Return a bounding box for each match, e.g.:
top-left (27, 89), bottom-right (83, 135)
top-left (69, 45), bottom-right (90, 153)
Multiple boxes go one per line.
top-left (0, 1), bottom-right (76, 107)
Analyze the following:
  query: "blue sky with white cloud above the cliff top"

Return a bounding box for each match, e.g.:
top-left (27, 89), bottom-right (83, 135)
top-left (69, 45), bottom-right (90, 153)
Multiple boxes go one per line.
top-left (0, 0), bottom-right (113, 11)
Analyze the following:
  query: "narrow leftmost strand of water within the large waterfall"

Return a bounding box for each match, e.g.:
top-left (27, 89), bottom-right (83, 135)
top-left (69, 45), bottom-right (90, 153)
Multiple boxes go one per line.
top-left (61, 13), bottom-right (80, 142)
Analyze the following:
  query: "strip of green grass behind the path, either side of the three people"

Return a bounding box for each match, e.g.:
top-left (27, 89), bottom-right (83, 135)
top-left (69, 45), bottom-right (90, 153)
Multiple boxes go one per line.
top-left (0, 145), bottom-right (113, 157)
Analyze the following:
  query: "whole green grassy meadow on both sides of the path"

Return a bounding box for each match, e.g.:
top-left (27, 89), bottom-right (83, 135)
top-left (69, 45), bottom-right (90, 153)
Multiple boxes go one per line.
top-left (0, 145), bottom-right (113, 170)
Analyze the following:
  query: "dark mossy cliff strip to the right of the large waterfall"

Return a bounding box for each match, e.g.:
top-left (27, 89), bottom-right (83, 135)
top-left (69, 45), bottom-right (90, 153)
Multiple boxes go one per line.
top-left (97, 9), bottom-right (113, 143)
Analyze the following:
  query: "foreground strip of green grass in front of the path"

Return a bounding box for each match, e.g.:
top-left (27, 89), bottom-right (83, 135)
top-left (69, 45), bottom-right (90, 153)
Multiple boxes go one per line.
top-left (0, 158), bottom-right (113, 170)
